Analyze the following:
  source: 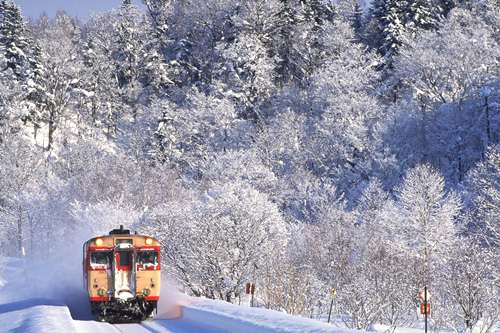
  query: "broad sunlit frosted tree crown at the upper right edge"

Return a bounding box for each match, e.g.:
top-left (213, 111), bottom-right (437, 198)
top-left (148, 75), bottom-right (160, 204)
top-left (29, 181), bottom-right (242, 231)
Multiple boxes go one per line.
top-left (394, 9), bottom-right (499, 105)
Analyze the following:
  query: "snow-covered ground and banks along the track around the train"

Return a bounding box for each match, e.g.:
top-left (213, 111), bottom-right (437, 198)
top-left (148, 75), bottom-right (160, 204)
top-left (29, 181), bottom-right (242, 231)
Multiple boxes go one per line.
top-left (0, 257), bottom-right (354, 333)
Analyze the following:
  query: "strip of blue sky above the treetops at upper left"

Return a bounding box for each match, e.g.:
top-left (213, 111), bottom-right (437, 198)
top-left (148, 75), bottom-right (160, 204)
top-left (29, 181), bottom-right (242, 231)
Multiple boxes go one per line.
top-left (14, 0), bottom-right (145, 19)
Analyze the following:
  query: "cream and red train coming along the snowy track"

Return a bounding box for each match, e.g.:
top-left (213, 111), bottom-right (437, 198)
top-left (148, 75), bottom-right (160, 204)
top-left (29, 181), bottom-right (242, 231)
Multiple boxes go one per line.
top-left (83, 226), bottom-right (161, 323)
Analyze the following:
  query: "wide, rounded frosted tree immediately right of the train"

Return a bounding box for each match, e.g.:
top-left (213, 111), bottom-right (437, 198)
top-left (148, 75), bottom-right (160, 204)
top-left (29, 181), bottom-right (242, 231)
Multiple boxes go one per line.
top-left (146, 182), bottom-right (287, 301)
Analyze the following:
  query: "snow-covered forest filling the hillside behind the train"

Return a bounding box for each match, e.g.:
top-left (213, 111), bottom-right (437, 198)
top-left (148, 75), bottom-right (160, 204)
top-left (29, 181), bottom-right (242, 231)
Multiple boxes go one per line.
top-left (0, 0), bottom-right (500, 333)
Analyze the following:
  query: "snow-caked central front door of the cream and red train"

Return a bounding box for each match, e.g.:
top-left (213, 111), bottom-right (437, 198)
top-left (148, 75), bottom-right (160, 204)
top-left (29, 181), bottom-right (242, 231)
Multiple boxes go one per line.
top-left (114, 249), bottom-right (135, 300)
